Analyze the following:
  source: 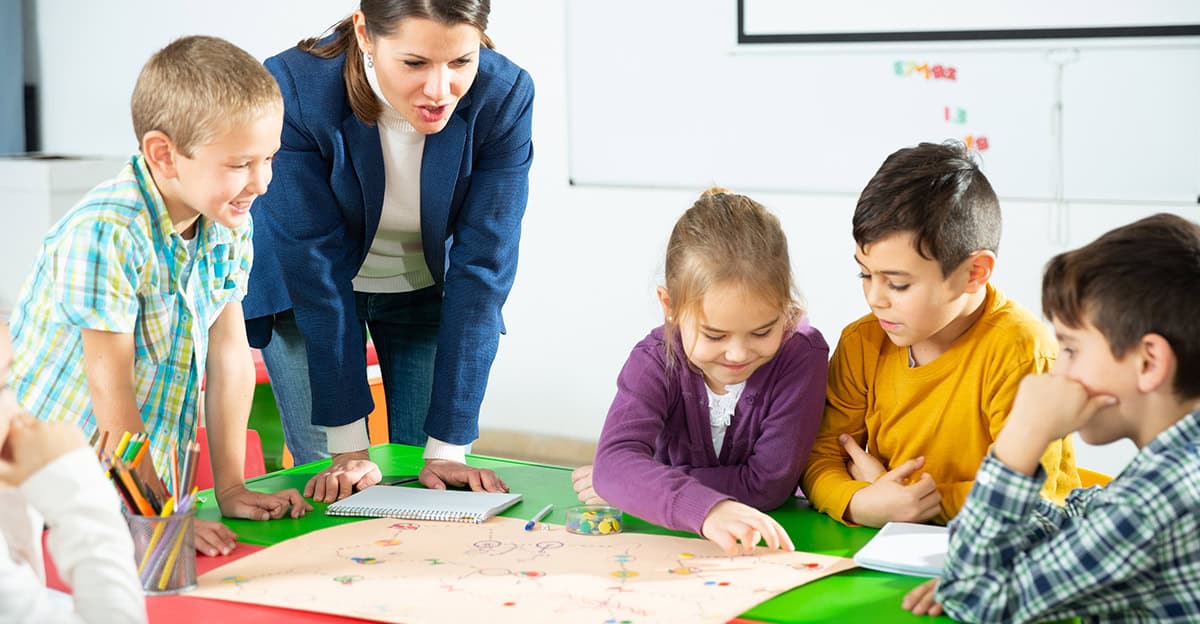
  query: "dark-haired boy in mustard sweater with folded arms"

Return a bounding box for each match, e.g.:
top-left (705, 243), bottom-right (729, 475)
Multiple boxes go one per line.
top-left (802, 143), bottom-right (1080, 527)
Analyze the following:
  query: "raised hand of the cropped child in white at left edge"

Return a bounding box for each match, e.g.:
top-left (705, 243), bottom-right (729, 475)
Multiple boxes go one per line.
top-left (0, 413), bottom-right (88, 486)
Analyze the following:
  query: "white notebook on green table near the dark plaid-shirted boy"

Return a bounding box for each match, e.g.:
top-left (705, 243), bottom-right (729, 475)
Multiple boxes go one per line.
top-left (854, 522), bottom-right (950, 576)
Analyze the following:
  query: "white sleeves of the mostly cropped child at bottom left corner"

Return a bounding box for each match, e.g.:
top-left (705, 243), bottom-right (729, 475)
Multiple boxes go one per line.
top-left (0, 449), bottom-right (146, 623)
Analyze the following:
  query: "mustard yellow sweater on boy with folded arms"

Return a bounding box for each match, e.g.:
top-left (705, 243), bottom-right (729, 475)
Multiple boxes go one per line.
top-left (802, 284), bottom-right (1080, 524)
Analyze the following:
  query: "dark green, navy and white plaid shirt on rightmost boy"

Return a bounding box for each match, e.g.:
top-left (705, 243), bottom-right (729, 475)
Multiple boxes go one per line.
top-left (936, 412), bottom-right (1200, 622)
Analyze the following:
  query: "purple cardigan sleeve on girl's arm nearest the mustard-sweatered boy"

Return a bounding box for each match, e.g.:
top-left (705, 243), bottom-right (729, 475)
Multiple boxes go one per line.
top-left (688, 330), bottom-right (829, 511)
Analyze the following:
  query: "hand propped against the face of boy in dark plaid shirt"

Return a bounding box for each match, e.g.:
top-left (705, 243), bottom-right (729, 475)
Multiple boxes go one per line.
top-left (992, 374), bottom-right (1117, 475)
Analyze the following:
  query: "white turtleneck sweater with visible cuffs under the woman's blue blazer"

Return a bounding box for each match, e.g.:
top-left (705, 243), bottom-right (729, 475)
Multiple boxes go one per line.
top-left (325, 54), bottom-right (470, 463)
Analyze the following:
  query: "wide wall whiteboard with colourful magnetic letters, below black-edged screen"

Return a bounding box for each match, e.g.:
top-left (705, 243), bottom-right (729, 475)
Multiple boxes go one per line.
top-left (566, 0), bottom-right (1200, 202)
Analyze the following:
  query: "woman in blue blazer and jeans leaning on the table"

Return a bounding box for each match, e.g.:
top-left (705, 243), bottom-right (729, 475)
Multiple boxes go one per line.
top-left (244, 0), bottom-right (534, 500)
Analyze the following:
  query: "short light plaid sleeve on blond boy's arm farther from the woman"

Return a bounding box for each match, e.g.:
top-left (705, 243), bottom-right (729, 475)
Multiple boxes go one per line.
top-left (46, 218), bottom-right (139, 334)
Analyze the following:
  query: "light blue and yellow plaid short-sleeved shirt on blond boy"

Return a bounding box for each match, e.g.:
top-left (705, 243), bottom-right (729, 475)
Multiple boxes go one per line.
top-left (12, 155), bottom-right (253, 474)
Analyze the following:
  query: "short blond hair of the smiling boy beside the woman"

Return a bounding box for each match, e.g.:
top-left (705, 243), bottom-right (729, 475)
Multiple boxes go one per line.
top-left (131, 35), bottom-right (283, 157)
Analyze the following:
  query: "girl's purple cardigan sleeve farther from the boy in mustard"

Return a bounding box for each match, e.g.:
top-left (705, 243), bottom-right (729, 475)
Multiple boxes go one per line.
top-left (592, 338), bottom-right (730, 534)
